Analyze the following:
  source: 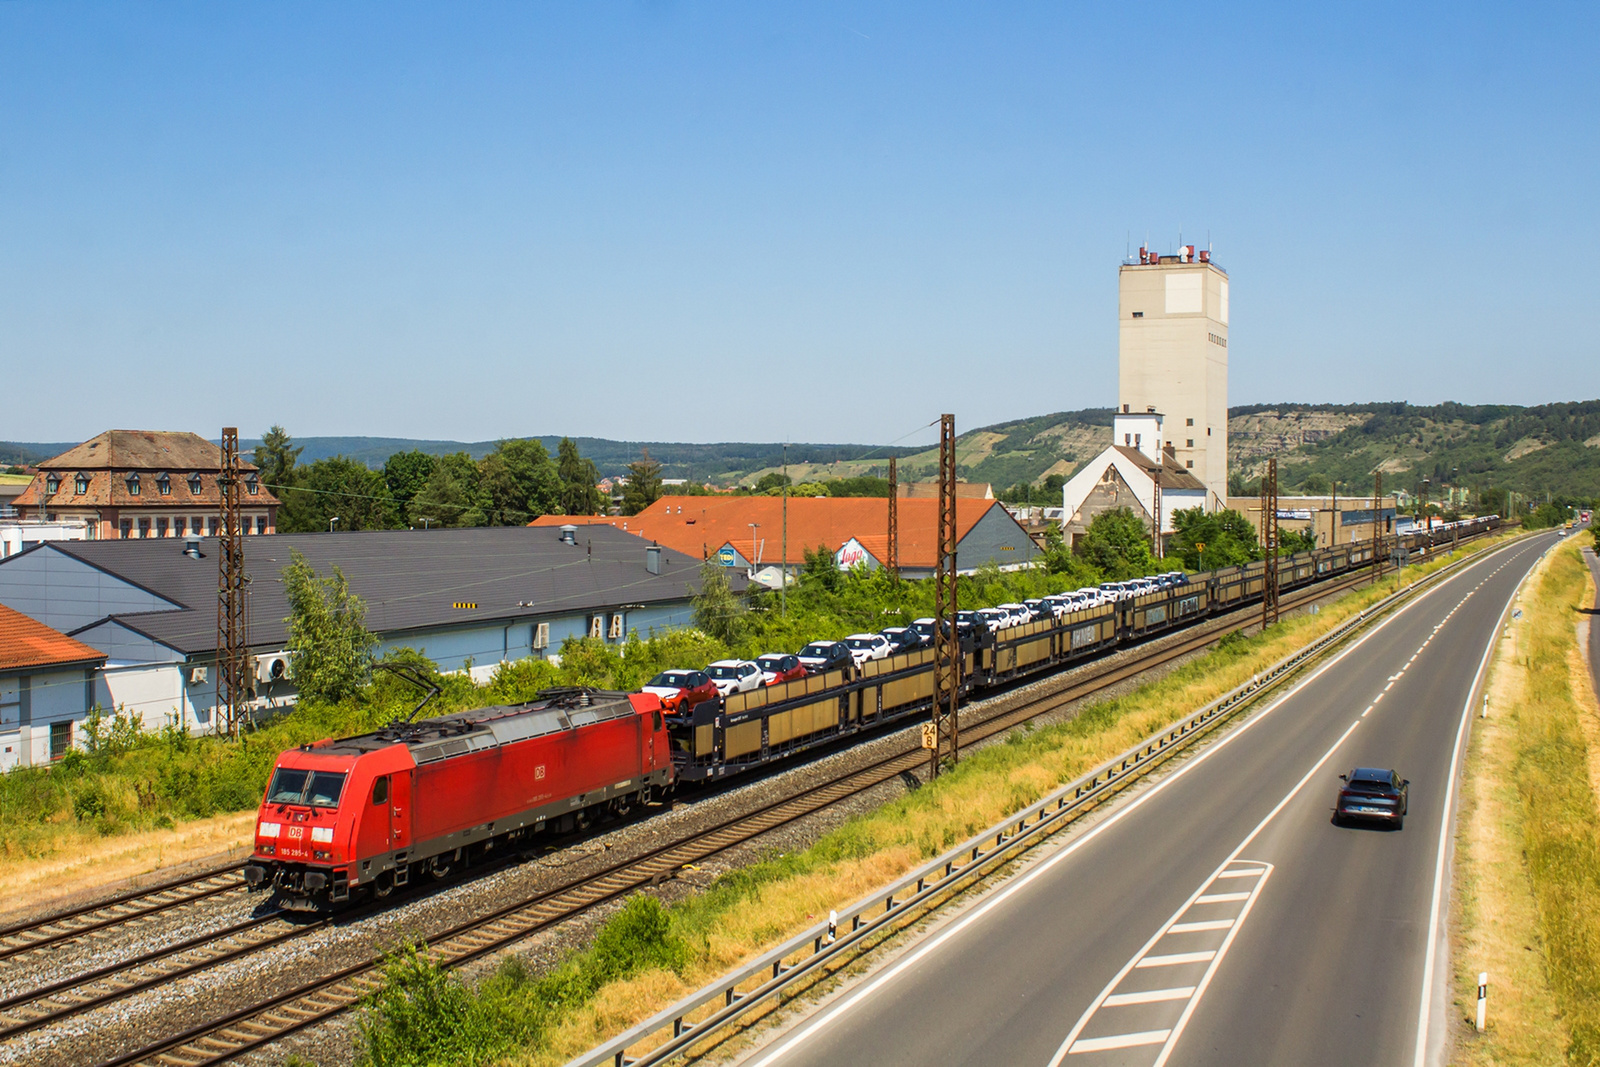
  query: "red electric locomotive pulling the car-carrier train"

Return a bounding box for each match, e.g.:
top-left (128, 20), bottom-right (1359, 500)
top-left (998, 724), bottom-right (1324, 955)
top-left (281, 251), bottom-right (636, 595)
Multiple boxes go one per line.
top-left (245, 689), bottom-right (672, 910)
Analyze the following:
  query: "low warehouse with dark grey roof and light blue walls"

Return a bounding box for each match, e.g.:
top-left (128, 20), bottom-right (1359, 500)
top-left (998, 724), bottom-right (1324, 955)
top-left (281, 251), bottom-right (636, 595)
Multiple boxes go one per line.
top-left (0, 526), bottom-right (720, 731)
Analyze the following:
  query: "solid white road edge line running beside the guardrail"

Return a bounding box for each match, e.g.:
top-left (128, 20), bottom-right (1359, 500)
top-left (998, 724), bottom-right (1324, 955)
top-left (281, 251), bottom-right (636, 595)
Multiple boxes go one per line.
top-left (736, 541), bottom-right (1522, 1067)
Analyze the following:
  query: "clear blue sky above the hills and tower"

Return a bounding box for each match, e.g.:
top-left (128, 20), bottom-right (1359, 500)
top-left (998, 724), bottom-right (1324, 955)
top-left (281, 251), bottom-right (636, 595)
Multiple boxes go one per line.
top-left (0, 2), bottom-right (1600, 443)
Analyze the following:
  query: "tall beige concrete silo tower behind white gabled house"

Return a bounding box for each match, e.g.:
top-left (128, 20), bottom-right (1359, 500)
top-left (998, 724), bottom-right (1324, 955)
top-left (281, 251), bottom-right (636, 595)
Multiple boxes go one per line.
top-left (1117, 262), bottom-right (1229, 507)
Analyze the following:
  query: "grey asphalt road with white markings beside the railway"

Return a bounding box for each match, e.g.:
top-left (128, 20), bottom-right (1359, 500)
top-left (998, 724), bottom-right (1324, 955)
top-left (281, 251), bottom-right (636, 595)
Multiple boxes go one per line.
top-left (746, 534), bottom-right (1554, 1067)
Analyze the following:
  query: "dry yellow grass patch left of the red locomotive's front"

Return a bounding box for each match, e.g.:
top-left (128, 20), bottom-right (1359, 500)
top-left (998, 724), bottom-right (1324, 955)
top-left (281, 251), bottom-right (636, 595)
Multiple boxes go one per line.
top-left (0, 811), bottom-right (256, 912)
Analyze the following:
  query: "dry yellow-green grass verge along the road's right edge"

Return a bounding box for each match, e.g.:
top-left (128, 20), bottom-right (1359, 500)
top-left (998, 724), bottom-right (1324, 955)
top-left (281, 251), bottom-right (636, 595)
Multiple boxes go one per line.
top-left (1451, 541), bottom-right (1600, 1064)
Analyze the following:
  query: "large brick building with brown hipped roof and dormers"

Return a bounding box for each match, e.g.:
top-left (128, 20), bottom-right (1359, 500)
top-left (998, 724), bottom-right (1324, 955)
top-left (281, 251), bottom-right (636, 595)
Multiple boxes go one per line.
top-left (14, 430), bottom-right (278, 541)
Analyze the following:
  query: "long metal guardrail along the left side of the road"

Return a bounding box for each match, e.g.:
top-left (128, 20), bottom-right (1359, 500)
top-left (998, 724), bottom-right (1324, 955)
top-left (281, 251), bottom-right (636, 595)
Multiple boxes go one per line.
top-left (566, 543), bottom-right (1510, 1067)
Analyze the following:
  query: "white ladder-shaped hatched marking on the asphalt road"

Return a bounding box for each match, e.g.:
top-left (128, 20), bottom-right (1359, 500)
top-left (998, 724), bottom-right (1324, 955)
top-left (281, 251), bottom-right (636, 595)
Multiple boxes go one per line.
top-left (1050, 857), bottom-right (1272, 1067)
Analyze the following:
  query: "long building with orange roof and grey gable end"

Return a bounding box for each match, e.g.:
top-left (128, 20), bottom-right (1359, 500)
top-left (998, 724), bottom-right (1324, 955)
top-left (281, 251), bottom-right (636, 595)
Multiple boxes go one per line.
top-left (534, 496), bottom-right (1040, 589)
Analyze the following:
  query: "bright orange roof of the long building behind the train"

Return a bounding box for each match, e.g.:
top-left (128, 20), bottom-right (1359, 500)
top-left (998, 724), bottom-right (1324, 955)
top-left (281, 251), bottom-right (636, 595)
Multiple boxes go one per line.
top-left (604, 496), bottom-right (1000, 568)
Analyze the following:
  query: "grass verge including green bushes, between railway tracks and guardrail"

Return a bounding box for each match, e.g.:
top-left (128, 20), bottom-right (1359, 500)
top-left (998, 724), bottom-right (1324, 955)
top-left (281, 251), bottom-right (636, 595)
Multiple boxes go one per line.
top-left (360, 545), bottom-right (1523, 1067)
